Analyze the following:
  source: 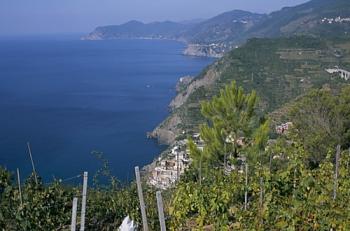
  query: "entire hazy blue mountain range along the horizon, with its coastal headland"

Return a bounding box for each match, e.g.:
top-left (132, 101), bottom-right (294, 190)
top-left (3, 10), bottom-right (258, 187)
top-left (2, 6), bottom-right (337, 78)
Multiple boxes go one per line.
top-left (83, 0), bottom-right (350, 57)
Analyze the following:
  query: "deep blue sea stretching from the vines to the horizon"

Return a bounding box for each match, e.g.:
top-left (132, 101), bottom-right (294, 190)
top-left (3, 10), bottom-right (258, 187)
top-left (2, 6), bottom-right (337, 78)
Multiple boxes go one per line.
top-left (0, 37), bottom-right (213, 182)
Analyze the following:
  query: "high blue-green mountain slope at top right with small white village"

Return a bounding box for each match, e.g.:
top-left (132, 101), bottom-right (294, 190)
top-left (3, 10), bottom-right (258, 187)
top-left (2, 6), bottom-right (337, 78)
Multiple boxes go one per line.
top-left (244, 0), bottom-right (350, 38)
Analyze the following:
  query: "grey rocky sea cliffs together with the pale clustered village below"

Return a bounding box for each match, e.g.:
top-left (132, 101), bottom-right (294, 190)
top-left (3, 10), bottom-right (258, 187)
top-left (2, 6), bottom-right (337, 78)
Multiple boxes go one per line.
top-left (142, 62), bottom-right (220, 189)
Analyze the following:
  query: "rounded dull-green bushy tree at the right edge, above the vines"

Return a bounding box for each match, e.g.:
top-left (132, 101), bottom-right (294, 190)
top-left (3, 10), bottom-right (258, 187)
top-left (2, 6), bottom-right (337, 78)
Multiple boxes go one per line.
top-left (290, 87), bottom-right (350, 166)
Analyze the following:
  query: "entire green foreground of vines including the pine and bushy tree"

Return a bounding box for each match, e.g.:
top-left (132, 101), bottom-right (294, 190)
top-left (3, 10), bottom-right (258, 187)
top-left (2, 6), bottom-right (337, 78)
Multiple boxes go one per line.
top-left (0, 82), bottom-right (350, 231)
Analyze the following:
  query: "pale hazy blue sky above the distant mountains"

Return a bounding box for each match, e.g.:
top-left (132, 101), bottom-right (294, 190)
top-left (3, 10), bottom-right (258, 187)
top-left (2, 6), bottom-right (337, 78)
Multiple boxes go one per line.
top-left (0, 0), bottom-right (307, 35)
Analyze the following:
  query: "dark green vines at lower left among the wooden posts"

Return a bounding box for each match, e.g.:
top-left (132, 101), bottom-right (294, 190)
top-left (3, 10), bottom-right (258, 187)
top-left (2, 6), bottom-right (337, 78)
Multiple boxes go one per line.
top-left (0, 157), bottom-right (159, 231)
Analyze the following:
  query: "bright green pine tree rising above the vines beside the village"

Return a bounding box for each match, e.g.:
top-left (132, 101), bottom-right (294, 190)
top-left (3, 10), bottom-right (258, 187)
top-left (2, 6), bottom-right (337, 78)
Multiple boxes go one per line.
top-left (189, 82), bottom-right (268, 179)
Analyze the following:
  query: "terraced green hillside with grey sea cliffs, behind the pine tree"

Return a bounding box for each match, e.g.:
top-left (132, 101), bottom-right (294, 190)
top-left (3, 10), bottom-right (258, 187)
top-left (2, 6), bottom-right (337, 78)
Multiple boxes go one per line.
top-left (153, 37), bottom-right (350, 143)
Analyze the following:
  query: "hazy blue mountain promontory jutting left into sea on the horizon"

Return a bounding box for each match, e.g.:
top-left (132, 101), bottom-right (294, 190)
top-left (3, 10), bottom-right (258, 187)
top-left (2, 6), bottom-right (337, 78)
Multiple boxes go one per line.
top-left (83, 10), bottom-right (266, 44)
